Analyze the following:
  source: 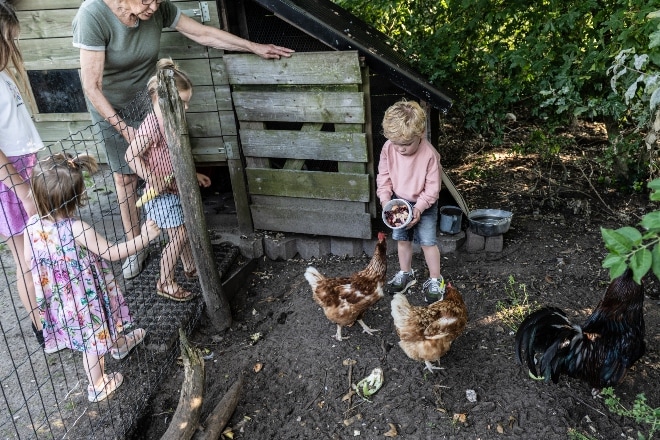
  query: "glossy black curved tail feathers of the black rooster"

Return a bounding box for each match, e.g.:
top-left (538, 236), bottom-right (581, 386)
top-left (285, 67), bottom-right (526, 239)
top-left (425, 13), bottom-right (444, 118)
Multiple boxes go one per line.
top-left (514, 307), bottom-right (572, 376)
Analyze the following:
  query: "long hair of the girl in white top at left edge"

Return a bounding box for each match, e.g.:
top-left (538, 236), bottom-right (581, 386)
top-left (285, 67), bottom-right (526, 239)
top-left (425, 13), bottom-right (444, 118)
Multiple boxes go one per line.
top-left (0, 0), bottom-right (30, 96)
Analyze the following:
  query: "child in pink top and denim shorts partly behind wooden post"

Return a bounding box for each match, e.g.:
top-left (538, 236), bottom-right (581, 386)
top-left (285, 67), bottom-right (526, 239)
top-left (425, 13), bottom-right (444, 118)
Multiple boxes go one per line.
top-left (126, 58), bottom-right (211, 301)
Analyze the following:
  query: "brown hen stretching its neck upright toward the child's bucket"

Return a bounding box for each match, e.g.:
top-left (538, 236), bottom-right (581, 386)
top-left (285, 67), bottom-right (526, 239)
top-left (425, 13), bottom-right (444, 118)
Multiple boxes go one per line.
top-left (305, 232), bottom-right (387, 341)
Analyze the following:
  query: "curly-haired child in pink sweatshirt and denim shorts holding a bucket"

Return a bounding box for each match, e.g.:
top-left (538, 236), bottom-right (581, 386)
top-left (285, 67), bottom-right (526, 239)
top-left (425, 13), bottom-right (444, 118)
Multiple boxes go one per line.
top-left (376, 101), bottom-right (445, 302)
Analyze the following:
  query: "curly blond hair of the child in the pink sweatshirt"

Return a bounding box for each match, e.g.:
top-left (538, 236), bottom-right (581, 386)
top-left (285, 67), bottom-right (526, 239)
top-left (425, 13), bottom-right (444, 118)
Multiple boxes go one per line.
top-left (383, 100), bottom-right (426, 145)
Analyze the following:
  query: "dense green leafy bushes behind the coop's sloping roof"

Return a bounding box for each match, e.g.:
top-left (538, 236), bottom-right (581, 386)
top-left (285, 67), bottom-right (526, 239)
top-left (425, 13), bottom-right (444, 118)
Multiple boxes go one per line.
top-left (334, 0), bottom-right (660, 180)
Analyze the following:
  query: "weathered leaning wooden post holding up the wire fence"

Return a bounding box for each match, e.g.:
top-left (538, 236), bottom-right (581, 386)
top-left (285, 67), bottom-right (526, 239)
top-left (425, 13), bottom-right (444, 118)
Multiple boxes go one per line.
top-left (158, 70), bottom-right (232, 331)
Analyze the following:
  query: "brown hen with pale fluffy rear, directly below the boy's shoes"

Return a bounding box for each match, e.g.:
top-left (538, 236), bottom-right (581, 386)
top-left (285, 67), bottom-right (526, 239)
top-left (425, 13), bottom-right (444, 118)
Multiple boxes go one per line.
top-left (392, 284), bottom-right (468, 372)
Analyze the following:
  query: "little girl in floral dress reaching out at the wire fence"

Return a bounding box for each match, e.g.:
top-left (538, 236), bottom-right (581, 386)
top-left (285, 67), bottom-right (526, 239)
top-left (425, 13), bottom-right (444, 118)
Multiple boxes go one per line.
top-left (25, 153), bottom-right (160, 402)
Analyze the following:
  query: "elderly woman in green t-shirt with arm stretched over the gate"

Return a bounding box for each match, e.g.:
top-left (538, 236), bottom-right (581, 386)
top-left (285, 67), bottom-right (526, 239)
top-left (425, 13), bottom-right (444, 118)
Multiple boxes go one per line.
top-left (73, 0), bottom-right (293, 279)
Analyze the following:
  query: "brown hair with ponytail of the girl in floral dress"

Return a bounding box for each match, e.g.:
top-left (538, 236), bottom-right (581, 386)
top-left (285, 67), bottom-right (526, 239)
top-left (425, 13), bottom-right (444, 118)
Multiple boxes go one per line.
top-left (31, 153), bottom-right (98, 219)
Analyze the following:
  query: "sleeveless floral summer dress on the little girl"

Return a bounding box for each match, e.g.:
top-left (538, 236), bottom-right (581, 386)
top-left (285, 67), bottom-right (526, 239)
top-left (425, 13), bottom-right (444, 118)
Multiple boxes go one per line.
top-left (25, 216), bottom-right (132, 356)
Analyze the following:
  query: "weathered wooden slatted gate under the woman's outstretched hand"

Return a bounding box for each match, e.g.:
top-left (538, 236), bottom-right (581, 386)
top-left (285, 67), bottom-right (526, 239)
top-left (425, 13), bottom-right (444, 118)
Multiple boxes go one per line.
top-left (224, 51), bottom-right (373, 238)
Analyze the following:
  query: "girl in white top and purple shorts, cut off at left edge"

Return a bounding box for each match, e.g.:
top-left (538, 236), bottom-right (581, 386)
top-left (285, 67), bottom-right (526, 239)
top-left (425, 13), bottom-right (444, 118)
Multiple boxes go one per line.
top-left (0, 1), bottom-right (43, 345)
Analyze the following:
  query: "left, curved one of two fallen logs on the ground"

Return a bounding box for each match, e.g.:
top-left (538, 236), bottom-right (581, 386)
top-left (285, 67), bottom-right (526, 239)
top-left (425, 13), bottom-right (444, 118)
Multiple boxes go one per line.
top-left (161, 329), bottom-right (205, 440)
